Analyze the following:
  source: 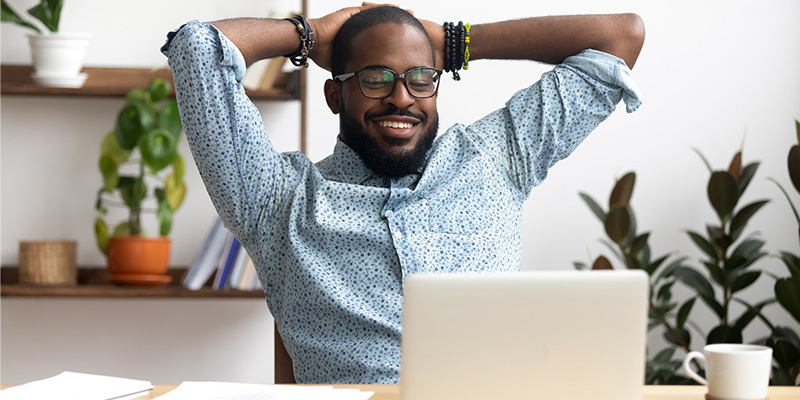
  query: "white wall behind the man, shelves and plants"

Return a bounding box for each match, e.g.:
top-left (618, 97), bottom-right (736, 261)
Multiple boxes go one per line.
top-left (0, 0), bottom-right (800, 383)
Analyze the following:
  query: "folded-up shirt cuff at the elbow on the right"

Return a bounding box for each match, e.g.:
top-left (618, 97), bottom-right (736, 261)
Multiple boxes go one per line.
top-left (564, 49), bottom-right (642, 113)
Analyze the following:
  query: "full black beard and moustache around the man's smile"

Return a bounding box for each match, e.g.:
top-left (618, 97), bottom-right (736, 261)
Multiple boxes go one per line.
top-left (339, 105), bottom-right (439, 178)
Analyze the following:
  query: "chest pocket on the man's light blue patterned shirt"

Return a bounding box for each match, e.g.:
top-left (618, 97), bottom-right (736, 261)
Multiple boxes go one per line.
top-left (428, 178), bottom-right (489, 234)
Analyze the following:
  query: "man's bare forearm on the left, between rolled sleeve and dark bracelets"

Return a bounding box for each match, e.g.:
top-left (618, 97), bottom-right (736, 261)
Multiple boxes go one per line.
top-left (211, 18), bottom-right (300, 65)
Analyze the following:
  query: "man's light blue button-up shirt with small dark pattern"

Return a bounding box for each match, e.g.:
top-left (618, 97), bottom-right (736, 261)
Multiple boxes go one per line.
top-left (162, 21), bottom-right (640, 383)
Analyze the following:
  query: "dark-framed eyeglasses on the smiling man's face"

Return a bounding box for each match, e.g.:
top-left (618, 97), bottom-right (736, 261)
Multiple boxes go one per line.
top-left (334, 67), bottom-right (442, 99)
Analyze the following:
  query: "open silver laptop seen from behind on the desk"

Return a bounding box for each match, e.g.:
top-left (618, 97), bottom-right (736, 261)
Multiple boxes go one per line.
top-left (400, 271), bottom-right (649, 400)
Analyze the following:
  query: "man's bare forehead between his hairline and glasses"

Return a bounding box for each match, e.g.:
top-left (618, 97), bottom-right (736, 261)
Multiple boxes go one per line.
top-left (345, 22), bottom-right (434, 71)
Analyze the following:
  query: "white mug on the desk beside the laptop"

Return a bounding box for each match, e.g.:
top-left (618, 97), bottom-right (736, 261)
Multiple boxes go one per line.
top-left (683, 343), bottom-right (772, 400)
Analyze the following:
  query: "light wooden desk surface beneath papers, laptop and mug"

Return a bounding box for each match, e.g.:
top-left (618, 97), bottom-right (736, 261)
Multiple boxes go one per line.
top-left (144, 385), bottom-right (800, 400)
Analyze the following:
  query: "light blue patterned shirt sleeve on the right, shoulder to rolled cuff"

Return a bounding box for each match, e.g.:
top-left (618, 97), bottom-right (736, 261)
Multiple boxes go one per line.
top-left (467, 49), bottom-right (641, 196)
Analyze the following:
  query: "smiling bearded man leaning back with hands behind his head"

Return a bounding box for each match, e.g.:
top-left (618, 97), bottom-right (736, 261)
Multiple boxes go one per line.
top-left (163, 3), bottom-right (644, 383)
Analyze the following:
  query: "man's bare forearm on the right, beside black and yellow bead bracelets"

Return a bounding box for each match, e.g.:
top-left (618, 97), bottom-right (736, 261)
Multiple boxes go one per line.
top-left (462, 14), bottom-right (644, 68)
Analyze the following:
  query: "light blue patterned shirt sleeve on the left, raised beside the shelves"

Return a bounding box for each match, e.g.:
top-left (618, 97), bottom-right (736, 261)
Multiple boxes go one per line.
top-left (161, 21), bottom-right (304, 239)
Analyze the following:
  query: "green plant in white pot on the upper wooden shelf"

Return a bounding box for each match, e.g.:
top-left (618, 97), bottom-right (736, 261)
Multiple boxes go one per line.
top-left (0, 0), bottom-right (91, 87)
